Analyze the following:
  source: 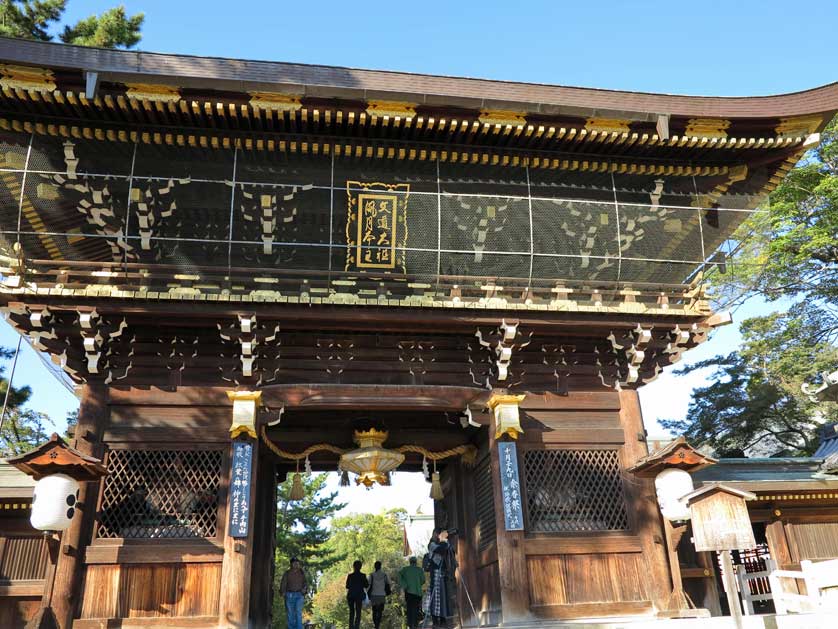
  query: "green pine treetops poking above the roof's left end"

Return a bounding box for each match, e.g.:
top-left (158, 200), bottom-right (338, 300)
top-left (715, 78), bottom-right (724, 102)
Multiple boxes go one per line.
top-left (0, 0), bottom-right (145, 48)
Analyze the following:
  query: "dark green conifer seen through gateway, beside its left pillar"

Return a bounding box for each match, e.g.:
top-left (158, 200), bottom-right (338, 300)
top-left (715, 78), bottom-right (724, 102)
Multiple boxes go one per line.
top-left (273, 474), bottom-right (345, 628)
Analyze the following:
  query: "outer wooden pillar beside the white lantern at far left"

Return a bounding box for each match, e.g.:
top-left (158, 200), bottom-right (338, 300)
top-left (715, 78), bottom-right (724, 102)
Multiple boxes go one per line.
top-left (49, 382), bottom-right (110, 629)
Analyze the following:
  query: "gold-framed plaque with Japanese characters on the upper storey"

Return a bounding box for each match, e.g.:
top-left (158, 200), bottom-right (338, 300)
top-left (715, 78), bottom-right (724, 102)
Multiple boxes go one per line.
top-left (345, 181), bottom-right (410, 273)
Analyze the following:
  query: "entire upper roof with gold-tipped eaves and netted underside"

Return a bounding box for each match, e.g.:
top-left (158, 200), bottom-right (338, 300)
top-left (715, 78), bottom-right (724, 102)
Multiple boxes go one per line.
top-left (0, 38), bottom-right (838, 314)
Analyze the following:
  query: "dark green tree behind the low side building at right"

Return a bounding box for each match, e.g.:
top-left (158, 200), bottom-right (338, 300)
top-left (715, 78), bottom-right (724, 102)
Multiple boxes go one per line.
top-left (661, 302), bottom-right (838, 456)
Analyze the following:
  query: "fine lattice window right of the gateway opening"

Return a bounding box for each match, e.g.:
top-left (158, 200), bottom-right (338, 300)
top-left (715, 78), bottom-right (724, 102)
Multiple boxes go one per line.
top-left (524, 450), bottom-right (629, 533)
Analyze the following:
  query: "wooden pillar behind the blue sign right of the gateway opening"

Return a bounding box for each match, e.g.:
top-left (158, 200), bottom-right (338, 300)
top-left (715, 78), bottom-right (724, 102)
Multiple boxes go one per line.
top-left (489, 418), bottom-right (532, 624)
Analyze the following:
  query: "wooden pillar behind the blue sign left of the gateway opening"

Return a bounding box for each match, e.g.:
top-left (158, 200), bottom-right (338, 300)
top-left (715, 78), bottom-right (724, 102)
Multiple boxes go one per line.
top-left (218, 439), bottom-right (263, 629)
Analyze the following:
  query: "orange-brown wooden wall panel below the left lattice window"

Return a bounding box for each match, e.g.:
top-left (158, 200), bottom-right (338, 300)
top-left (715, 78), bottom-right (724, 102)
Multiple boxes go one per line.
top-left (81, 563), bottom-right (221, 618)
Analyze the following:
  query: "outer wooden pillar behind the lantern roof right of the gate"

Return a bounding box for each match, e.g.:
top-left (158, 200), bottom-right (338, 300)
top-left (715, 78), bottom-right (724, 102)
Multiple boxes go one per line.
top-left (620, 390), bottom-right (681, 610)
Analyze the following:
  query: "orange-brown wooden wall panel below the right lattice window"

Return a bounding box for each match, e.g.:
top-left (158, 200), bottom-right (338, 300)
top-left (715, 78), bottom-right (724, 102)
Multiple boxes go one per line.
top-left (527, 553), bottom-right (650, 606)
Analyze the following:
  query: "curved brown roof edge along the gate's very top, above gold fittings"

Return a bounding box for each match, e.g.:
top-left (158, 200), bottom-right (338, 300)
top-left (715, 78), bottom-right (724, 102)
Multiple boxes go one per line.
top-left (0, 38), bottom-right (838, 120)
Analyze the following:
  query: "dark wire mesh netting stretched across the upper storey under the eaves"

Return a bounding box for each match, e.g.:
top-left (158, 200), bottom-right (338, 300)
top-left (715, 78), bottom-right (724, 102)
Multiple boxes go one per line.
top-left (0, 132), bottom-right (753, 292)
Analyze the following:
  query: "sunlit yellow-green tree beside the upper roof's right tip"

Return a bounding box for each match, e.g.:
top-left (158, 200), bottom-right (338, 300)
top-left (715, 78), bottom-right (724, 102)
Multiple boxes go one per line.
top-left (710, 117), bottom-right (838, 342)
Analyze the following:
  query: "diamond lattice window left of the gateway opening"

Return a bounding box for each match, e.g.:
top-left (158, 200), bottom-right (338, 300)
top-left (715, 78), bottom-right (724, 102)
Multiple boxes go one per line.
top-left (97, 450), bottom-right (221, 538)
